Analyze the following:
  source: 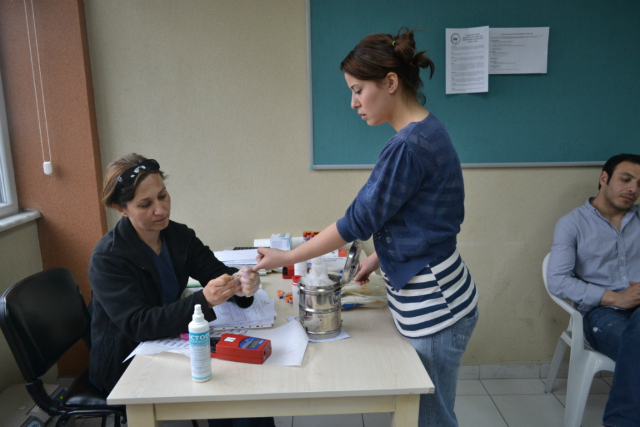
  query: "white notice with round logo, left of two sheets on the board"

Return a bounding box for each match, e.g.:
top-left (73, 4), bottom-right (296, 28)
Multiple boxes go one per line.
top-left (445, 26), bottom-right (489, 94)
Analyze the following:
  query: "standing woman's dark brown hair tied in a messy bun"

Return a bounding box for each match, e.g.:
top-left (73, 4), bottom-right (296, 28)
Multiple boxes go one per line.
top-left (340, 27), bottom-right (434, 105)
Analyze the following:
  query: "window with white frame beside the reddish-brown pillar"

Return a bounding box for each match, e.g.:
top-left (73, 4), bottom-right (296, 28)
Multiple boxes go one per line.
top-left (0, 69), bottom-right (18, 218)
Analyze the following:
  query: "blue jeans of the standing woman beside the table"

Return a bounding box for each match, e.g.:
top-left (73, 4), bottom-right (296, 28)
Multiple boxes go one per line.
top-left (408, 308), bottom-right (478, 427)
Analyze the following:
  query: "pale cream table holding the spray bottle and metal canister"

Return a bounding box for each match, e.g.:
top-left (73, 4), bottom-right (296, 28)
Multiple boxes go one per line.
top-left (107, 274), bottom-right (434, 427)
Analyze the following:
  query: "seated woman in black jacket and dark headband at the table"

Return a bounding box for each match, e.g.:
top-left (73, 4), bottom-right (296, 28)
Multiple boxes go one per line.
top-left (89, 153), bottom-right (274, 427)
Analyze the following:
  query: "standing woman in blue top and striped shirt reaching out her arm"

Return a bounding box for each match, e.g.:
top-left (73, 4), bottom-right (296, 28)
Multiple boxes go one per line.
top-left (254, 29), bottom-right (478, 427)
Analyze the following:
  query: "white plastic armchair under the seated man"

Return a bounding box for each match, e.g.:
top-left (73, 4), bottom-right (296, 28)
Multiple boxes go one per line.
top-left (542, 254), bottom-right (616, 427)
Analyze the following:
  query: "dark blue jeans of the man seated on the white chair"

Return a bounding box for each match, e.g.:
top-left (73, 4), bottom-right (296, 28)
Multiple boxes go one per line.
top-left (584, 307), bottom-right (640, 427)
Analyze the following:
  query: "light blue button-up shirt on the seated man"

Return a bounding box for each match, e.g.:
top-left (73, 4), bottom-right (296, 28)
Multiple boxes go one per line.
top-left (547, 199), bottom-right (640, 312)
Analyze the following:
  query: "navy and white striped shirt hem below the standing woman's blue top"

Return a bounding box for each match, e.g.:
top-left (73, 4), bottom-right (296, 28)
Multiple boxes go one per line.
top-left (382, 250), bottom-right (478, 338)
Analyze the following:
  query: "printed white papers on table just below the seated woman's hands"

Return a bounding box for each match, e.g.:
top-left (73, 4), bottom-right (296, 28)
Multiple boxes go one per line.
top-left (209, 289), bottom-right (277, 329)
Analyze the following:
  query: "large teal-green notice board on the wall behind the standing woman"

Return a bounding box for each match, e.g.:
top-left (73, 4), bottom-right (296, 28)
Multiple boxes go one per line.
top-left (307, 0), bottom-right (640, 169)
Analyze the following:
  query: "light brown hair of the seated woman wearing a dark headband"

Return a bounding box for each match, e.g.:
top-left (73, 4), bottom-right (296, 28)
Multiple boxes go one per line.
top-left (100, 153), bottom-right (165, 208)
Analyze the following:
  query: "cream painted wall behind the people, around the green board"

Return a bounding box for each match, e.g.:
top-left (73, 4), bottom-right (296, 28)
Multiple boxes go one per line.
top-left (85, 0), bottom-right (599, 364)
